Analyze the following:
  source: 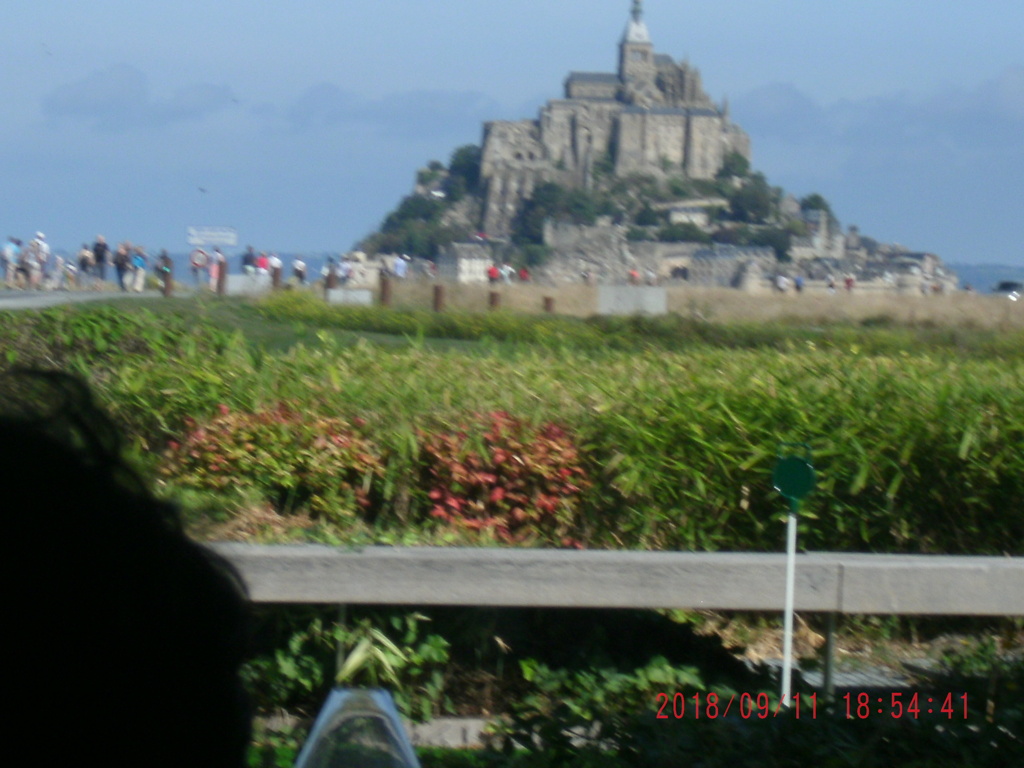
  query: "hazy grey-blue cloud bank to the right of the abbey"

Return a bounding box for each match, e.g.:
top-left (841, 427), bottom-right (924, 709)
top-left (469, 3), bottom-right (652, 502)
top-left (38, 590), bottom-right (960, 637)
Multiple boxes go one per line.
top-left (733, 67), bottom-right (1024, 262)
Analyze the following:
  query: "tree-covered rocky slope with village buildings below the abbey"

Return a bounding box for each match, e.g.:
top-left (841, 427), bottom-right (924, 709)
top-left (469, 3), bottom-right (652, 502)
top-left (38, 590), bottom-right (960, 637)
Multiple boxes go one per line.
top-left (360, 144), bottom-right (955, 290)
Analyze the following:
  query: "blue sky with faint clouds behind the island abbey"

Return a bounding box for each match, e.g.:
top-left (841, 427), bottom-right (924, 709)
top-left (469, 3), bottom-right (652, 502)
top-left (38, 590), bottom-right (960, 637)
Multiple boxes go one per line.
top-left (0, 0), bottom-right (1024, 264)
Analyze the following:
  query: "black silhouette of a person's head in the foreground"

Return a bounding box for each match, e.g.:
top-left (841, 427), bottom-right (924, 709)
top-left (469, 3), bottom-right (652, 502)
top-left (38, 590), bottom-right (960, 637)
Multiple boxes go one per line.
top-left (0, 372), bottom-right (250, 768)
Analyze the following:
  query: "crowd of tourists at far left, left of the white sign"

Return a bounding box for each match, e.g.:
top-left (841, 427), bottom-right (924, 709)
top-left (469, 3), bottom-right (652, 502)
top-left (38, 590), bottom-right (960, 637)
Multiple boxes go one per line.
top-left (0, 232), bottom-right (170, 293)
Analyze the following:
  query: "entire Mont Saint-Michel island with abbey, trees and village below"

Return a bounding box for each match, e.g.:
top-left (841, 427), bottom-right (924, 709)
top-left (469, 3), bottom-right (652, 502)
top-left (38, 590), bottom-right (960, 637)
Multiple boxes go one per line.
top-left (362, 0), bottom-right (956, 293)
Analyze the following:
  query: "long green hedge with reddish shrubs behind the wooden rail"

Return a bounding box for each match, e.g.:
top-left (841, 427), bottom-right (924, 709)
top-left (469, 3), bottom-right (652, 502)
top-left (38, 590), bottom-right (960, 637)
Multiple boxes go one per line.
top-left (8, 301), bottom-right (1024, 554)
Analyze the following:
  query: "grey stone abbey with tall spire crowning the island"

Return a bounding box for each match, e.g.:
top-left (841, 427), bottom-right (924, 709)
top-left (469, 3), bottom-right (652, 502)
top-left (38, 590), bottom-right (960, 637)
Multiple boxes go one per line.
top-left (481, 0), bottom-right (751, 237)
